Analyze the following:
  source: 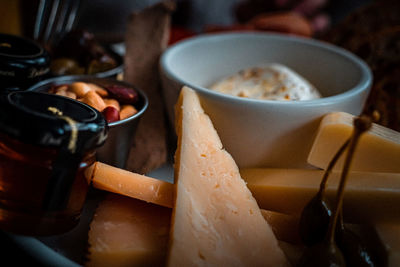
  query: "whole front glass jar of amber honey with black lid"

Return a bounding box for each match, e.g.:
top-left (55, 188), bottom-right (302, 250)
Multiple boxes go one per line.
top-left (0, 92), bottom-right (107, 235)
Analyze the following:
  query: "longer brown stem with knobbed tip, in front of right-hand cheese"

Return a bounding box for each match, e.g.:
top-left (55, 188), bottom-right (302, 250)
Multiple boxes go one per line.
top-left (328, 115), bottom-right (372, 243)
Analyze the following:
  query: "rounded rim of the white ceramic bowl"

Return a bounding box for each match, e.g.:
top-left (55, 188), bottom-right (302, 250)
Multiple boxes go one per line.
top-left (160, 32), bottom-right (372, 107)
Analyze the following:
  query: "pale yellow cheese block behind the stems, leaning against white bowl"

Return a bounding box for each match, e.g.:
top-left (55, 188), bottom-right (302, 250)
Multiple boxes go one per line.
top-left (308, 112), bottom-right (400, 172)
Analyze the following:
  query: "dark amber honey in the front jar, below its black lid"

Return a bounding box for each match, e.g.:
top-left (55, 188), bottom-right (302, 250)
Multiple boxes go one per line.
top-left (0, 134), bottom-right (95, 235)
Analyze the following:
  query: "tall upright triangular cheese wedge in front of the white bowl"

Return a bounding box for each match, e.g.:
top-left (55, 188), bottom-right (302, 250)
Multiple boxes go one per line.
top-left (167, 87), bottom-right (288, 266)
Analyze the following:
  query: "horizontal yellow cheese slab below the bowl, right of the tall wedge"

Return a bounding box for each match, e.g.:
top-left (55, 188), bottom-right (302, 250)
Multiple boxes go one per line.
top-left (240, 169), bottom-right (400, 222)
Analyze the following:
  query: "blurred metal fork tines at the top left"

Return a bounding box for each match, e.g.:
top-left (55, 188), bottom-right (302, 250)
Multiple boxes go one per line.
top-left (33, 0), bottom-right (80, 45)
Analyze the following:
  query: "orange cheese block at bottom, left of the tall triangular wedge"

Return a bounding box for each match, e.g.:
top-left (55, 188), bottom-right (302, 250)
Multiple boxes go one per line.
top-left (85, 194), bottom-right (171, 267)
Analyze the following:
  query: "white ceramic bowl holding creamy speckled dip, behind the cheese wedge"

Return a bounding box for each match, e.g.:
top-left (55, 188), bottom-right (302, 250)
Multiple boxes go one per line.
top-left (160, 33), bottom-right (372, 167)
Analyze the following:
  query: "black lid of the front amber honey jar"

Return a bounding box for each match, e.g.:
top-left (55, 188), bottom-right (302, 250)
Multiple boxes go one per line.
top-left (0, 91), bottom-right (107, 151)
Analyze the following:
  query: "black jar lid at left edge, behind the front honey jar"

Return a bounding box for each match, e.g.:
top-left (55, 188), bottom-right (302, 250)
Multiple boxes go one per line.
top-left (0, 34), bottom-right (50, 89)
